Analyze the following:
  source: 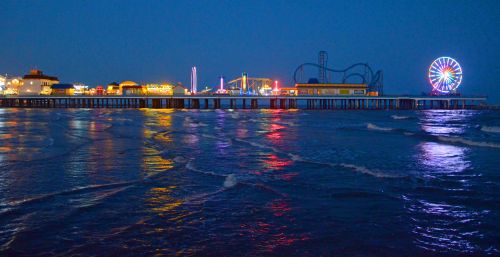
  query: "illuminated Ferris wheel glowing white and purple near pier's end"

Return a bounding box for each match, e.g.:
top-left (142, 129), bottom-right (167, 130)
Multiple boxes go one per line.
top-left (429, 57), bottom-right (462, 94)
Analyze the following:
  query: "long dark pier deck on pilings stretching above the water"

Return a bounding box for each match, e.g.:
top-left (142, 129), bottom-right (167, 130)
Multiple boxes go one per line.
top-left (0, 95), bottom-right (488, 110)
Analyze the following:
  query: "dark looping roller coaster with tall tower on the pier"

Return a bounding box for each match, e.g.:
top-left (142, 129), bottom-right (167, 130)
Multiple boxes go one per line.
top-left (293, 51), bottom-right (384, 95)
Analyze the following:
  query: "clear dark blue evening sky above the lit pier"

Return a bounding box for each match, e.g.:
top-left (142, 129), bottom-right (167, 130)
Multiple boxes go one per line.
top-left (0, 0), bottom-right (500, 102)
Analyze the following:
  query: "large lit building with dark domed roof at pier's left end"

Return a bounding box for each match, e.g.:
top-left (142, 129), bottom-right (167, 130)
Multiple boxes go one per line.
top-left (22, 69), bottom-right (59, 95)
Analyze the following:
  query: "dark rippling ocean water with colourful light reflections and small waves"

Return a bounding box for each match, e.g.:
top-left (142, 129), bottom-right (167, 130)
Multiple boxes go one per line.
top-left (0, 109), bottom-right (500, 256)
